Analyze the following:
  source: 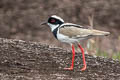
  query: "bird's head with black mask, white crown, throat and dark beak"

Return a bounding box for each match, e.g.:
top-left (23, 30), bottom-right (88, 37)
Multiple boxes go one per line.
top-left (42, 15), bottom-right (64, 31)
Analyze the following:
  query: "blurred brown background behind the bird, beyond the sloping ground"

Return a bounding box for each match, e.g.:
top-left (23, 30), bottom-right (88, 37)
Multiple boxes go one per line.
top-left (0, 0), bottom-right (120, 60)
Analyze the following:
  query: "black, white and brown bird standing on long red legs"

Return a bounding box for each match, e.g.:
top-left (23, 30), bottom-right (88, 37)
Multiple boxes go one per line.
top-left (41, 15), bottom-right (110, 71)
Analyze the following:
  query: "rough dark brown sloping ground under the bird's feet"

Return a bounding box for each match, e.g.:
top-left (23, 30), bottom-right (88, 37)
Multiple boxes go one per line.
top-left (0, 38), bottom-right (120, 80)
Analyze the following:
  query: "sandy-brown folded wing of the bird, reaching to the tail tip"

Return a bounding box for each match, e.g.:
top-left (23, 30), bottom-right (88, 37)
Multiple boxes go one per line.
top-left (59, 26), bottom-right (109, 38)
